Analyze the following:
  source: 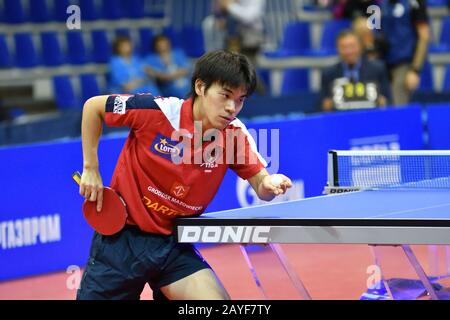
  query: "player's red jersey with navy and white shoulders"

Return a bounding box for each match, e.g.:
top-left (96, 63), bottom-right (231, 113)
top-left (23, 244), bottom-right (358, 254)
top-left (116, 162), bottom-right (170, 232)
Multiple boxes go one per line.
top-left (105, 94), bottom-right (267, 234)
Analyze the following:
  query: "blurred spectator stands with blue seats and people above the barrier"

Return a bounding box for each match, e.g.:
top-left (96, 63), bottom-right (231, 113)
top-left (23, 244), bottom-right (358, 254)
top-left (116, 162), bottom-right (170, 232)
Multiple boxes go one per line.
top-left (0, 0), bottom-right (450, 145)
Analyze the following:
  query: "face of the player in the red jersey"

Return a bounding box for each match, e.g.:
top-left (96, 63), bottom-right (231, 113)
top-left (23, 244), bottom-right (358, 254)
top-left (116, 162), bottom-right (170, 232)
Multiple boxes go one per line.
top-left (203, 83), bottom-right (247, 130)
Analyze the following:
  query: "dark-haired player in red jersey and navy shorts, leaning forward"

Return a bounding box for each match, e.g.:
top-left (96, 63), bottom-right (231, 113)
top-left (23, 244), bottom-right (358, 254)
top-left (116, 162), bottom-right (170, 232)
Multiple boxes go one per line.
top-left (77, 51), bottom-right (292, 299)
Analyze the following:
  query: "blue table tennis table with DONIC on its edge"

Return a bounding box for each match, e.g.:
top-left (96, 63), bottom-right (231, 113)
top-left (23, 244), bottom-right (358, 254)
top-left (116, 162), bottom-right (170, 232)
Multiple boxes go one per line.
top-left (175, 150), bottom-right (450, 299)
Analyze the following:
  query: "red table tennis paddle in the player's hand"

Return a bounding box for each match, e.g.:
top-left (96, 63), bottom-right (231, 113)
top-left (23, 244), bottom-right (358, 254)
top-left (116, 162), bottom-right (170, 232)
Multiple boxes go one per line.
top-left (72, 171), bottom-right (128, 236)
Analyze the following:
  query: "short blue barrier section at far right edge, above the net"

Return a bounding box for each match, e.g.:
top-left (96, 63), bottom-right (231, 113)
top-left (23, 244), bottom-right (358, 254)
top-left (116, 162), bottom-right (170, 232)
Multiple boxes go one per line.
top-left (427, 104), bottom-right (450, 150)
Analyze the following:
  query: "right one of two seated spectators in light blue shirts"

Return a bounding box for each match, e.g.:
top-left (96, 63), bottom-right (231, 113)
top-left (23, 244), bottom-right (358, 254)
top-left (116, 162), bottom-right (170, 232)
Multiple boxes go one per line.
top-left (145, 35), bottom-right (191, 98)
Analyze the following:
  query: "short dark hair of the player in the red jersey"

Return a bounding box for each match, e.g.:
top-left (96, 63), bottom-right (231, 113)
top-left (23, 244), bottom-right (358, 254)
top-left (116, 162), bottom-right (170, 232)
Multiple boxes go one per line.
top-left (190, 50), bottom-right (257, 100)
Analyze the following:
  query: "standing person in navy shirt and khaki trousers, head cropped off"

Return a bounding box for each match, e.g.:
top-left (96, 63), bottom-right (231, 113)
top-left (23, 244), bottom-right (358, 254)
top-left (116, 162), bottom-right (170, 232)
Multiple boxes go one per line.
top-left (381, 0), bottom-right (430, 105)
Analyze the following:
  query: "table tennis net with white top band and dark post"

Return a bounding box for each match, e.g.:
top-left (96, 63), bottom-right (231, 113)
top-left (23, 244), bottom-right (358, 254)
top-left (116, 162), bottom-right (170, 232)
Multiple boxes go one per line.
top-left (328, 151), bottom-right (450, 189)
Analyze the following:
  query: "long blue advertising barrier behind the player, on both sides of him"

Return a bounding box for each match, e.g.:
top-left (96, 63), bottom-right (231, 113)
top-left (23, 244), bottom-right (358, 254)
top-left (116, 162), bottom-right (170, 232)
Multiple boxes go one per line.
top-left (0, 107), bottom-right (423, 281)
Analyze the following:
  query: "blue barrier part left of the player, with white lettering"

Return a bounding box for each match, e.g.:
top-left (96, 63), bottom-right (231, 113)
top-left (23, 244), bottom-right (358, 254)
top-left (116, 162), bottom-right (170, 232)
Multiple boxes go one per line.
top-left (0, 138), bottom-right (124, 281)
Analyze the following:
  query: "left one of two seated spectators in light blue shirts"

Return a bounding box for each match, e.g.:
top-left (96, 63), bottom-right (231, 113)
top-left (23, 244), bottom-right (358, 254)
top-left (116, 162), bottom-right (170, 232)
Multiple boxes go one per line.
top-left (109, 36), bottom-right (160, 96)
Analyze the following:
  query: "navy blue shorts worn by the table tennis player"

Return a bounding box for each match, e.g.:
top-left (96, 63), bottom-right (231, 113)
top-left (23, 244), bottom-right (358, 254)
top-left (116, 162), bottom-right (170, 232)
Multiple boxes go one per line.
top-left (77, 225), bottom-right (211, 300)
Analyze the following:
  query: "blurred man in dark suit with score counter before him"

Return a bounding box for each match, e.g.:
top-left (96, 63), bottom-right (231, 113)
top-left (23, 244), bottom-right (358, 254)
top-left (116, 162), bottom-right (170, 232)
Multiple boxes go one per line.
top-left (321, 30), bottom-right (391, 111)
